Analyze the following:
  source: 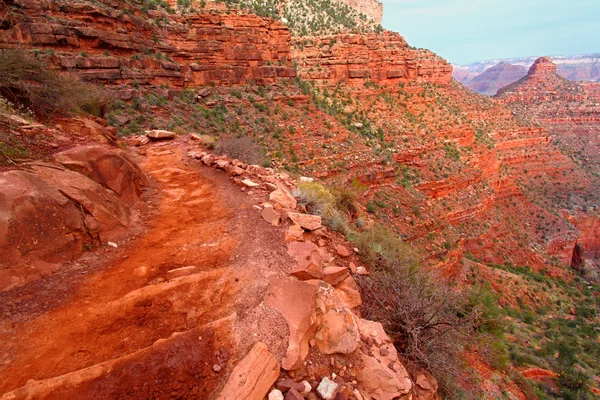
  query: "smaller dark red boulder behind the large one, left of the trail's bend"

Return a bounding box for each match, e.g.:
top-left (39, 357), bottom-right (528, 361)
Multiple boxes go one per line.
top-left (55, 145), bottom-right (147, 205)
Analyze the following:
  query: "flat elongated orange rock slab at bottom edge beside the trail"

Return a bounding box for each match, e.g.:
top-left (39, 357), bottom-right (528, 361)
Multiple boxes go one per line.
top-left (217, 342), bottom-right (279, 400)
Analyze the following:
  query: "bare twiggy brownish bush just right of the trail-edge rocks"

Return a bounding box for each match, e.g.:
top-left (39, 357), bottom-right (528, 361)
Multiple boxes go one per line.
top-left (354, 224), bottom-right (492, 394)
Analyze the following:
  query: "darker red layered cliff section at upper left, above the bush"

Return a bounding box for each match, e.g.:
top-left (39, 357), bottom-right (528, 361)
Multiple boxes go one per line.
top-left (0, 0), bottom-right (296, 86)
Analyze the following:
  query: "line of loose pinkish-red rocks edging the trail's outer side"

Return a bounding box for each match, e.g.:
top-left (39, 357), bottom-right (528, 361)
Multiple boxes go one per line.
top-left (188, 141), bottom-right (437, 400)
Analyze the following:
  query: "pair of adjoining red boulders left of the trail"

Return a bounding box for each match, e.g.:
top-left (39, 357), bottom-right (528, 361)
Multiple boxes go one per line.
top-left (0, 145), bottom-right (146, 291)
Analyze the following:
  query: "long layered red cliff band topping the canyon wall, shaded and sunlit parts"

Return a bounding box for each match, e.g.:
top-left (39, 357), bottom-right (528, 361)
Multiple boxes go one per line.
top-left (0, 0), bottom-right (452, 89)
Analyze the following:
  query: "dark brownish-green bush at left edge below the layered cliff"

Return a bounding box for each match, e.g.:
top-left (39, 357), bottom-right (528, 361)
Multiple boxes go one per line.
top-left (0, 49), bottom-right (112, 117)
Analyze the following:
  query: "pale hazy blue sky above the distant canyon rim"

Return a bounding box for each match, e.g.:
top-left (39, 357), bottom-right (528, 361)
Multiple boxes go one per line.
top-left (380, 0), bottom-right (600, 64)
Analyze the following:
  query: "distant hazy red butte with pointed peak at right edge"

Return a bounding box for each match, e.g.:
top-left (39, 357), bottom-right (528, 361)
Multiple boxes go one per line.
top-left (498, 57), bottom-right (600, 276)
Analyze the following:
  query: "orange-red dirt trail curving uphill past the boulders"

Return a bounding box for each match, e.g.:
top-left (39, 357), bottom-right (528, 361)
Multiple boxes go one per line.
top-left (0, 142), bottom-right (290, 399)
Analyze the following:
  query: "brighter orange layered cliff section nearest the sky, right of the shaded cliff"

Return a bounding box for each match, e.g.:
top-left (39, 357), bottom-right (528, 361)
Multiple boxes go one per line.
top-left (292, 31), bottom-right (452, 86)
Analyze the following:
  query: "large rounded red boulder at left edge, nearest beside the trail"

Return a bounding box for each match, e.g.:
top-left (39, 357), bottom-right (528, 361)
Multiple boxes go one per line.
top-left (0, 163), bottom-right (131, 291)
